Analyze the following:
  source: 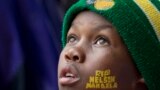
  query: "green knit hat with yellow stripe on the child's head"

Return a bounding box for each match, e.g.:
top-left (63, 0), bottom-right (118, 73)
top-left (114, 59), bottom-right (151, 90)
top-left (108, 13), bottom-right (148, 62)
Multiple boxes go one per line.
top-left (62, 0), bottom-right (160, 90)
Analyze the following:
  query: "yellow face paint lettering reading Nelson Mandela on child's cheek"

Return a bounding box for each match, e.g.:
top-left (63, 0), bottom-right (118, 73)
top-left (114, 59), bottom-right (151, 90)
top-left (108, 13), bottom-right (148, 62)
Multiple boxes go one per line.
top-left (86, 69), bottom-right (118, 89)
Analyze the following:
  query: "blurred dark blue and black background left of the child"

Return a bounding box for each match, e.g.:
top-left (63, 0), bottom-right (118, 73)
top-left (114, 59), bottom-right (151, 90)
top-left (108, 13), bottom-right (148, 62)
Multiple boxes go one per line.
top-left (0, 0), bottom-right (76, 90)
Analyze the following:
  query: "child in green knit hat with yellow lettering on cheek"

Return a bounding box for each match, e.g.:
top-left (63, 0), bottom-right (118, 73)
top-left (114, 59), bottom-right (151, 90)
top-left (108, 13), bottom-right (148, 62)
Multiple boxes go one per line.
top-left (58, 0), bottom-right (160, 90)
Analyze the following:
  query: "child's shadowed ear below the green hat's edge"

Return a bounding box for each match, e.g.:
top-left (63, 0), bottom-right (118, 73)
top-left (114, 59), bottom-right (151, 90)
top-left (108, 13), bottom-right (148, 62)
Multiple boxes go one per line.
top-left (134, 78), bottom-right (148, 90)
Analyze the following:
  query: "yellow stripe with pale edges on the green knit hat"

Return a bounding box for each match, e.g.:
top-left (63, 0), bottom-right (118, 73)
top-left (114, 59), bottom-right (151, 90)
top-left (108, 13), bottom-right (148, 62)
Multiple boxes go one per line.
top-left (134, 0), bottom-right (160, 41)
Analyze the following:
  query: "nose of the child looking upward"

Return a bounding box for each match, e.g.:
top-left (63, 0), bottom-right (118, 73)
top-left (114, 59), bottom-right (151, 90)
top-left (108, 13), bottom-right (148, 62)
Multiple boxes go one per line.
top-left (65, 47), bottom-right (85, 63)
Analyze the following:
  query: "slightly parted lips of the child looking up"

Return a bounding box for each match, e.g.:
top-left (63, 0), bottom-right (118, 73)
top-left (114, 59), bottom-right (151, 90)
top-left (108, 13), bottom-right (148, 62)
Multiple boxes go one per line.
top-left (59, 65), bottom-right (80, 85)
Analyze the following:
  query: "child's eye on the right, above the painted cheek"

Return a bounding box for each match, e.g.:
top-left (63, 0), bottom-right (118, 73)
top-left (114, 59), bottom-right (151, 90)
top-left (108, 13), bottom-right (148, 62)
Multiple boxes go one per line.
top-left (94, 37), bottom-right (109, 46)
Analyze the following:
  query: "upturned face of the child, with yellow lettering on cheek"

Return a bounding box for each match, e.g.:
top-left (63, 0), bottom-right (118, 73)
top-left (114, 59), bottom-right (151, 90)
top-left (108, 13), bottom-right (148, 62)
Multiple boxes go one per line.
top-left (58, 11), bottom-right (140, 90)
